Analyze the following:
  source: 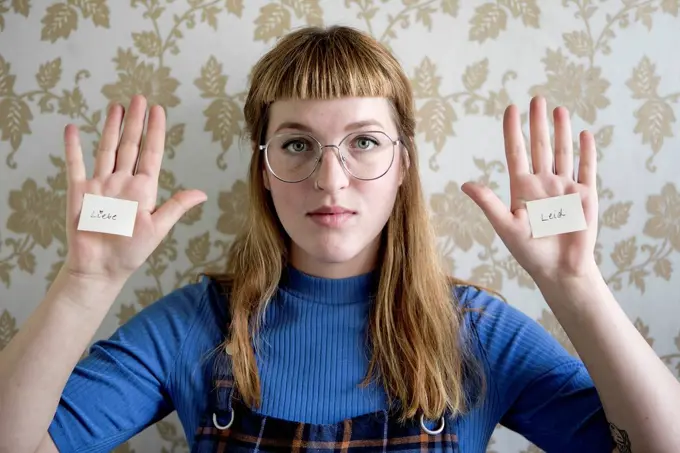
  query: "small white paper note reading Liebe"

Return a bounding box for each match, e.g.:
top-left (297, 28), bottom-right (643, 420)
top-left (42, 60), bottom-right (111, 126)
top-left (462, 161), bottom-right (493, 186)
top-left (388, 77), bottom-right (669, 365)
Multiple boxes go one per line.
top-left (78, 193), bottom-right (138, 236)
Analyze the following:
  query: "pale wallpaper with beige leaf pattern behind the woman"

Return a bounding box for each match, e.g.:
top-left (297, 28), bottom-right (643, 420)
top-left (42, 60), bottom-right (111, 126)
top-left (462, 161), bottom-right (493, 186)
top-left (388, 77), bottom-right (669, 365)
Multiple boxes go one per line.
top-left (0, 0), bottom-right (680, 453)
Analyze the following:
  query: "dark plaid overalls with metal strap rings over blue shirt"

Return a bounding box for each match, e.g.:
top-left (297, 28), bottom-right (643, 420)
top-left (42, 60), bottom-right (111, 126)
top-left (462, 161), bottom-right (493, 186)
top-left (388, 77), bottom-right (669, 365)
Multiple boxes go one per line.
top-left (191, 354), bottom-right (459, 453)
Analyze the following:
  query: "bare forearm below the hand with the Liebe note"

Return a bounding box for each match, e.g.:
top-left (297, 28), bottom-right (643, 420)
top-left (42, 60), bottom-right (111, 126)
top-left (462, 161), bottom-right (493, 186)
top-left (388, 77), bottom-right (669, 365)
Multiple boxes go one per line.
top-left (0, 268), bottom-right (123, 453)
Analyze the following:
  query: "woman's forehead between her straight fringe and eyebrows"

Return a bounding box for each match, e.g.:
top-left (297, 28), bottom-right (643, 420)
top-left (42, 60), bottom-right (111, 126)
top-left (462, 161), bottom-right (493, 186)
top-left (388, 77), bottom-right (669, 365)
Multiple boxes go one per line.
top-left (268, 97), bottom-right (395, 134)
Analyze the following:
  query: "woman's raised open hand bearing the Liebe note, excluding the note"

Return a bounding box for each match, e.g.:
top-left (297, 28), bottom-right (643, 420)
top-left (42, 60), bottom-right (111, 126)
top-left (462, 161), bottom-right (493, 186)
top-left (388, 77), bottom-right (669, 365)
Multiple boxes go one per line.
top-left (62, 96), bottom-right (207, 280)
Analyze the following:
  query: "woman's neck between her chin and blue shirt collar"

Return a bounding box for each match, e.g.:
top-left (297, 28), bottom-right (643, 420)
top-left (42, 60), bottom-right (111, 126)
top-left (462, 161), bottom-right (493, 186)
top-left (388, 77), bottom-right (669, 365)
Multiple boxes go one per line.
top-left (290, 241), bottom-right (380, 278)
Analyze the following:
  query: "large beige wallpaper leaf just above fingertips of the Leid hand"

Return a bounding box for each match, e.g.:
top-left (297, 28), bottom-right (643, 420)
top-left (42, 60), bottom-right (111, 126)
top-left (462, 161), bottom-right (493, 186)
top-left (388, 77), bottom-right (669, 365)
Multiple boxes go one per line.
top-left (529, 48), bottom-right (610, 124)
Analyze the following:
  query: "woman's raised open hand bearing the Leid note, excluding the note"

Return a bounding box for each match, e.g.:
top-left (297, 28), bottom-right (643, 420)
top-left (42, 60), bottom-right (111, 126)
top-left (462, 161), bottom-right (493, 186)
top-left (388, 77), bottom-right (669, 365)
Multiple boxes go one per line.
top-left (461, 97), bottom-right (598, 280)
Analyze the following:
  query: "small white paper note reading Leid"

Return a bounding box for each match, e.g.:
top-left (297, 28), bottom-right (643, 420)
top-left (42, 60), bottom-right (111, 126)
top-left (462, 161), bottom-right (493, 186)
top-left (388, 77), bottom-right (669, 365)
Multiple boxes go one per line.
top-left (527, 193), bottom-right (588, 238)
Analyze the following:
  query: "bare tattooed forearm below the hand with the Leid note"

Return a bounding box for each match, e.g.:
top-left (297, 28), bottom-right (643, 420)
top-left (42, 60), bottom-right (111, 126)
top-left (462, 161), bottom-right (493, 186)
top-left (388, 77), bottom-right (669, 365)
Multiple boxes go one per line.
top-left (537, 268), bottom-right (680, 453)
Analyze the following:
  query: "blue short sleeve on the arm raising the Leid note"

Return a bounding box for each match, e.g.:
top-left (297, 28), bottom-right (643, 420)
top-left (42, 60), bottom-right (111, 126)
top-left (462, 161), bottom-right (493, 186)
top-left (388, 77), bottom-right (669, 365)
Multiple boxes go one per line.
top-left (459, 287), bottom-right (615, 453)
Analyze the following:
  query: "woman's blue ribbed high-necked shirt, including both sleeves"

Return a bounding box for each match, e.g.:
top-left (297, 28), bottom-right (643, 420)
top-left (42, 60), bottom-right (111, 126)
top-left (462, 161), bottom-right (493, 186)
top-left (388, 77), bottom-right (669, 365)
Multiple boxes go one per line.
top-left (49, 268), bottom-right (612, 453)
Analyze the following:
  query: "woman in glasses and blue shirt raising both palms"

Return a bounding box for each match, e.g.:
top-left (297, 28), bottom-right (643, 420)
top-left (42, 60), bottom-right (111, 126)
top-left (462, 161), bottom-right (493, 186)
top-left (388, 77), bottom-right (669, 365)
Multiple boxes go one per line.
top-left (0, 27), bottom-right (680, 453)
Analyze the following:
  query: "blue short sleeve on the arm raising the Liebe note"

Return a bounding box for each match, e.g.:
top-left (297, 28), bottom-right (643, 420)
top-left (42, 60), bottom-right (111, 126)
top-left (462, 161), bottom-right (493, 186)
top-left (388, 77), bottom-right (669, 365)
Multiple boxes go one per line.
top-left (48, 281), bottom-right (211, 453)
